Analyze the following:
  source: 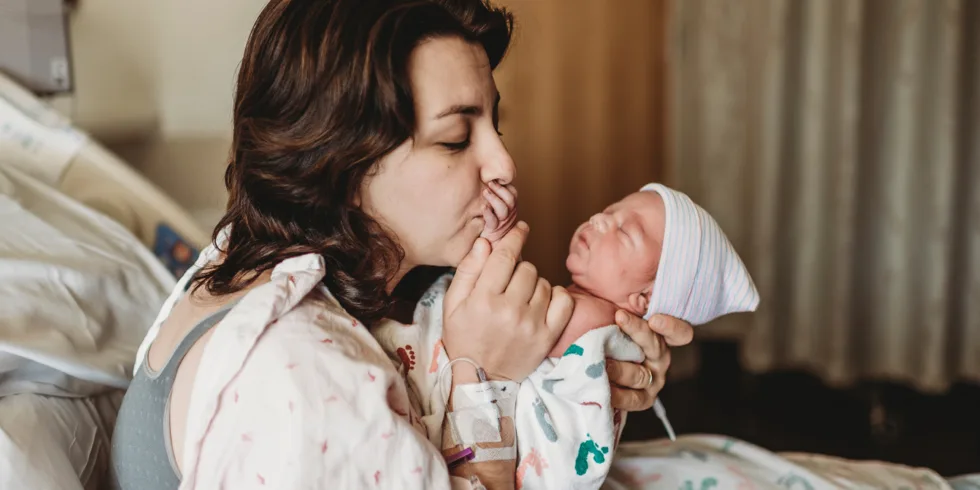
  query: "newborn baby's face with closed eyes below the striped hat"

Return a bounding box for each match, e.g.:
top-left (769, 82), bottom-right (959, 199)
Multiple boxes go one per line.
top-left (565, 192), bottom-right (666, 310)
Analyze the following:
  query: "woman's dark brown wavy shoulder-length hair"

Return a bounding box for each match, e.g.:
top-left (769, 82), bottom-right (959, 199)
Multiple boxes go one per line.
top-left (195, 0), bottom-right (513, 325)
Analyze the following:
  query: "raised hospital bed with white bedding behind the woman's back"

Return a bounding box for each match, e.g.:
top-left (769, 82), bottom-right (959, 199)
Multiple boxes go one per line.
top-left (0, 75), bottom-right (209, 490)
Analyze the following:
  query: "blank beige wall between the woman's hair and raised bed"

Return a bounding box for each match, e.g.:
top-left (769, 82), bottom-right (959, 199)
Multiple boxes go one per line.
top-left (63, 0), bottom-right (265, 226)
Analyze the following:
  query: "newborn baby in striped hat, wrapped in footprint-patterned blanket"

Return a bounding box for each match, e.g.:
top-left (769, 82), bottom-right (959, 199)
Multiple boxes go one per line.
top-left (374, 184), bottom-right (759, 489)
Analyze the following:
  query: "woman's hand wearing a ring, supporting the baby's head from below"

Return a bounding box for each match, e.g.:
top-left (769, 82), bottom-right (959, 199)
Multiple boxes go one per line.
top-left (606, 310), bottom-right (694, 412)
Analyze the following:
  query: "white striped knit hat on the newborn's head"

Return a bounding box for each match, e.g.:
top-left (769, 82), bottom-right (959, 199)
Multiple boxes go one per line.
top-left (641, 184), bottom-right (759, 325)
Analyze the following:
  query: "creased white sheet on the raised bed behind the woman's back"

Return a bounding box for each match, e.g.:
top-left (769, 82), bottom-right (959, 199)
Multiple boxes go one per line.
top-left (0, 163), bottom-right (175, 396)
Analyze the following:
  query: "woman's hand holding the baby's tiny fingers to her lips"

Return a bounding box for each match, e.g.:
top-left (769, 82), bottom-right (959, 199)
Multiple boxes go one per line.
top-left (442, 222), bottom-right (574, 382)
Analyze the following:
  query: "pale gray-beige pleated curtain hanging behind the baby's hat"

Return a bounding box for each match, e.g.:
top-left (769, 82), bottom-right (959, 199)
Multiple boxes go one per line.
top-left (667, 0), bottom-right (980, 391)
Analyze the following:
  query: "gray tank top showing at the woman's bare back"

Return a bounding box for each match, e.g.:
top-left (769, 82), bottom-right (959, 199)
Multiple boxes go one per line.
top-left (112, 299), bottom-right (240, 490)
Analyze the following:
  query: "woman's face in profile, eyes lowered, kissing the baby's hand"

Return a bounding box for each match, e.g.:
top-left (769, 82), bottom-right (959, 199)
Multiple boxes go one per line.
top-left (360, 37), bottom-right (515, 273)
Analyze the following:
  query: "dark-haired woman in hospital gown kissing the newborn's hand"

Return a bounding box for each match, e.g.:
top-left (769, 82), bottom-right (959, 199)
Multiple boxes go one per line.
top-left (113, 0), bottom-right (692, 490)
